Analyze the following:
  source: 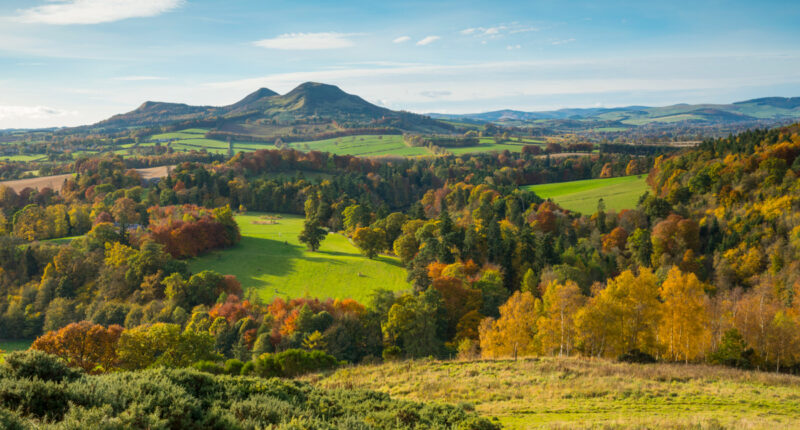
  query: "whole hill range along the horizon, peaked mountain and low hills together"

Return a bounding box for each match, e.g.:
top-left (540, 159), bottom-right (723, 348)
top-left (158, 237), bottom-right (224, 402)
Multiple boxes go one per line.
top-left (70, 82), bottom-right (800, 143)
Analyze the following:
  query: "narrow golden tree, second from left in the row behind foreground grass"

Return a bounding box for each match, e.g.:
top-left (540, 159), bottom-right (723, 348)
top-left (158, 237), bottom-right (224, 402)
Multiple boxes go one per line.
top-left (537, 281), bottom-right (586, 356)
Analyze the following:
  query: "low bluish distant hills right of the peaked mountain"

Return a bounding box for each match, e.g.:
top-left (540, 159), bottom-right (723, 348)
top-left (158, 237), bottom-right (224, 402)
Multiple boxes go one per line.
top-left (429, 97), bottom-right (800, 126)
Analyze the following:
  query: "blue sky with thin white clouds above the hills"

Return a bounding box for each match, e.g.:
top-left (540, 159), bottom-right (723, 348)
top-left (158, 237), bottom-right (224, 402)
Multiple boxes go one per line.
top-left (0, 0), bottom-right (800, 129)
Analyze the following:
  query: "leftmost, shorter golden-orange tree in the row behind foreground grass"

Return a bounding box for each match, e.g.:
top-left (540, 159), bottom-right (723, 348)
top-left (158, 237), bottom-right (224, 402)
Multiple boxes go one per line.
top-left (478, 291), bottom-right (542, 358)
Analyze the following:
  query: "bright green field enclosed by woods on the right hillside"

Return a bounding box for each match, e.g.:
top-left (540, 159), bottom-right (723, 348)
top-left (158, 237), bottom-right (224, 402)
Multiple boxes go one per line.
top-left (525, 175), bottom-right (648, 214)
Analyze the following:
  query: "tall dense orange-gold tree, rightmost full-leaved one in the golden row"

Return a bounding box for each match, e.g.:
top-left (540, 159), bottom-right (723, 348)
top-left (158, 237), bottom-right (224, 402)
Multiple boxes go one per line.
top-left (659, 267), bottom-right (709, 362)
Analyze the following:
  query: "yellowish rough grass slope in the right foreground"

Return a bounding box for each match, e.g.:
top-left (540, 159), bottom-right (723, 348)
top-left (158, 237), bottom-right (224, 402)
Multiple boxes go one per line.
top-left (306, 358), bottom-right (800, 429)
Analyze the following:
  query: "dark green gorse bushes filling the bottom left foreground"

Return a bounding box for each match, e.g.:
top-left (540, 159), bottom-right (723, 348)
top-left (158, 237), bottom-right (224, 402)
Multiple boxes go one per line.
top-left (0, 351), bottom-right (498, 430)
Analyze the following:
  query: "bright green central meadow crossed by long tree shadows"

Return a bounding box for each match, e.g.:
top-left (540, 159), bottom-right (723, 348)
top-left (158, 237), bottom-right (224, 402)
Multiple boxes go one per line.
top-left (189, 214), bottom-right (410, 302)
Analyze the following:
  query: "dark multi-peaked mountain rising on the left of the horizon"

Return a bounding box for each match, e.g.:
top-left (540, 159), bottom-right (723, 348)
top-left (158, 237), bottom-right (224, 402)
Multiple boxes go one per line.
top-left (85, 82), bottom-right (453, 137)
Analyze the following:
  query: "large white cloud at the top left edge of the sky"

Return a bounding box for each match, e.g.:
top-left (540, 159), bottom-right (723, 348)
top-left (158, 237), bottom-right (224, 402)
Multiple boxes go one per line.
top-left (17, 0), bottom-right (184, 25)
